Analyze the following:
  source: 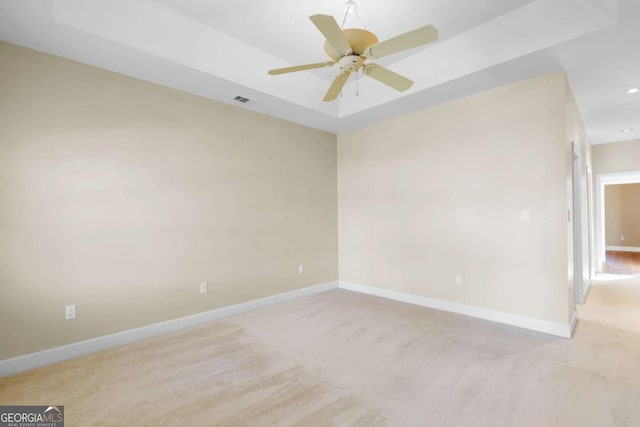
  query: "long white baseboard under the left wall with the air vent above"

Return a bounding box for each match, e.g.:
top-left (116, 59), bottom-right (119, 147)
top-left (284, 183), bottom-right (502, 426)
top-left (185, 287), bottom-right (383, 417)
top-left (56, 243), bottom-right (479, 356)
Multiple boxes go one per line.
top-left (0, 281), bottom-right (338, 378)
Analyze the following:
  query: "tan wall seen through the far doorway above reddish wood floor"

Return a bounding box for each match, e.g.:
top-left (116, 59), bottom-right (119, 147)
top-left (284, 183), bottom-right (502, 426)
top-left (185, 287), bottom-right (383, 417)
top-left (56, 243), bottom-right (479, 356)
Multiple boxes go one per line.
top-left (604, 184), bottom-right (640, 247)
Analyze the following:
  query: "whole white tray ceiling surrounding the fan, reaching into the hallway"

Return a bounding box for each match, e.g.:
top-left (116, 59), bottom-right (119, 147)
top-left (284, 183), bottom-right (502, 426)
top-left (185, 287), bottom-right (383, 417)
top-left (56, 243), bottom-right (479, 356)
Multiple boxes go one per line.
top-left (0, 0), bottom-right (640, 143)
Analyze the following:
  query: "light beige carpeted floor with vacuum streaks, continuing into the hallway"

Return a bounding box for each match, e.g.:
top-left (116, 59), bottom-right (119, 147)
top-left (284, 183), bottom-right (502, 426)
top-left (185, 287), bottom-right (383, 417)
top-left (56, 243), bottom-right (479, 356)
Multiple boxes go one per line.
top-left (0, 277), bottom-right (640, 427)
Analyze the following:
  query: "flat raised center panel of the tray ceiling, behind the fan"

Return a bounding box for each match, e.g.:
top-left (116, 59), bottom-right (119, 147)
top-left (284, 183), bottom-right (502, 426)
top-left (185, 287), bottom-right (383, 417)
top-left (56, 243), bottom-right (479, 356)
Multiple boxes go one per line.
top-left (154, 0), bottom-right (532, 65)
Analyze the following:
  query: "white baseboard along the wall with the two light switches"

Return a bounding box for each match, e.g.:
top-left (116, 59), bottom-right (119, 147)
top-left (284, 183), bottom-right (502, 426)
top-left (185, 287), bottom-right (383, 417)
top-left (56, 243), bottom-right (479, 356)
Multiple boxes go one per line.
top-left (339, 280), bottom-right (572, 338)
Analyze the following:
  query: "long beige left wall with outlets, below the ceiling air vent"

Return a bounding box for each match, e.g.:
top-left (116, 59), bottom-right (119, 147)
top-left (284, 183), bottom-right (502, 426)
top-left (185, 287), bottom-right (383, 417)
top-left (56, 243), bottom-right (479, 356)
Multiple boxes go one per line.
top-left (0, 43), bottom-right (338, 359)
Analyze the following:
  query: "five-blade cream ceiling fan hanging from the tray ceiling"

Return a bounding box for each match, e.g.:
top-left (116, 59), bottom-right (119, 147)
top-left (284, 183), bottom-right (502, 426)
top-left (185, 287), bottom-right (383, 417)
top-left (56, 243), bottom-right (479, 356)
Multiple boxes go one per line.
top-left (269, 0), bottom-right (438, 102)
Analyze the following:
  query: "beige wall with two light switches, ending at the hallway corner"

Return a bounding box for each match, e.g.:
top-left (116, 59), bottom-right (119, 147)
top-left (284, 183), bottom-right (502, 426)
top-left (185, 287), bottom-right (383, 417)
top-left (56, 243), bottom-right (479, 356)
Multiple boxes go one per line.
top-left (338, 72), bottom-right (573, 324)
